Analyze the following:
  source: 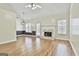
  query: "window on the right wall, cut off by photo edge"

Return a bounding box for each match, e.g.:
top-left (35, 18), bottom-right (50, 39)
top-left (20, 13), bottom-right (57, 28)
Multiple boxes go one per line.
top-left (71, 18), bottom-right (79, 35)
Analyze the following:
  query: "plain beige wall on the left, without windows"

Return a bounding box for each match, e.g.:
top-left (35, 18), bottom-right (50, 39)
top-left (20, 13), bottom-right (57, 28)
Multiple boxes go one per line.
top-left (0, 4), bottom-right (16, 44)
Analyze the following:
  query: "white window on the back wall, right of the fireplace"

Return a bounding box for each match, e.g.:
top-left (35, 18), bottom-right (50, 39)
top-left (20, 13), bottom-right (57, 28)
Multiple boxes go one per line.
top-left (58, 20), bottom-right (66, 34)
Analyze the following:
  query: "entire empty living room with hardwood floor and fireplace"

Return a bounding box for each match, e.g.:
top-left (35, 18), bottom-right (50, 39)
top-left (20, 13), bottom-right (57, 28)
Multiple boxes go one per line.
top-left (0, 3), bottom-right (79, 56)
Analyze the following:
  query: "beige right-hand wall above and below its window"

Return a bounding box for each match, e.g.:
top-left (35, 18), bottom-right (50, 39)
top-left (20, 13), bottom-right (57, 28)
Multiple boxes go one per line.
top-left (70, 3), bottom-right (79, 55)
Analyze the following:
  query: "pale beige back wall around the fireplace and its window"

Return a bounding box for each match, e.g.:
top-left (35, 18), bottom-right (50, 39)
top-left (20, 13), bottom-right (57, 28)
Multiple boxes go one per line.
top-left (23, 10), bottom-right (70, 39)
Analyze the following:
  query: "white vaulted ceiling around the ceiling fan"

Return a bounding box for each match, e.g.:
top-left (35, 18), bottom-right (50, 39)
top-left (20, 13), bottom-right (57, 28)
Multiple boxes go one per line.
top-left (7, 3), bottom-right (70, 19)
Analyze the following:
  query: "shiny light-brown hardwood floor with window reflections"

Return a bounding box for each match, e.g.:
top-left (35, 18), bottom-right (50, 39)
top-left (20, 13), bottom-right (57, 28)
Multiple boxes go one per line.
top-left (0, 36), bottom-right (75, 56)
